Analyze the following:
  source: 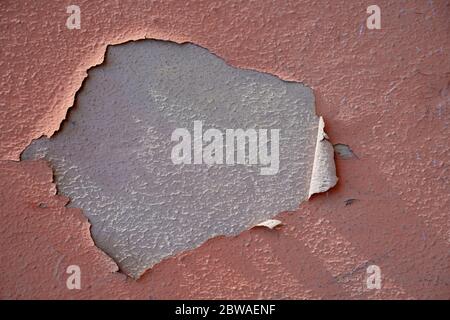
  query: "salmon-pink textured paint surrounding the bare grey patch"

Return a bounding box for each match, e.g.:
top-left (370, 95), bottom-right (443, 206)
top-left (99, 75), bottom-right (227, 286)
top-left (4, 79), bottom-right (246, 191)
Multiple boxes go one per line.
top-left (0, 0), bottom-right (450, 299)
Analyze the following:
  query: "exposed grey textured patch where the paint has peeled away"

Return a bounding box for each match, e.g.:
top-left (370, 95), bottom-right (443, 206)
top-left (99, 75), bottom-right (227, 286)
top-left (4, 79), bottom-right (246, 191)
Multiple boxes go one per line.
top-left (21, 40), bottom-right (335, 278)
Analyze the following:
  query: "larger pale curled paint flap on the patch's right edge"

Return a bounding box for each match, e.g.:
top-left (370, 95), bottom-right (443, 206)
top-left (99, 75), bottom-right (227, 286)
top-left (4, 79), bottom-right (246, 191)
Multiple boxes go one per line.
top-left (308, 117), bottom-right (338, 199)
